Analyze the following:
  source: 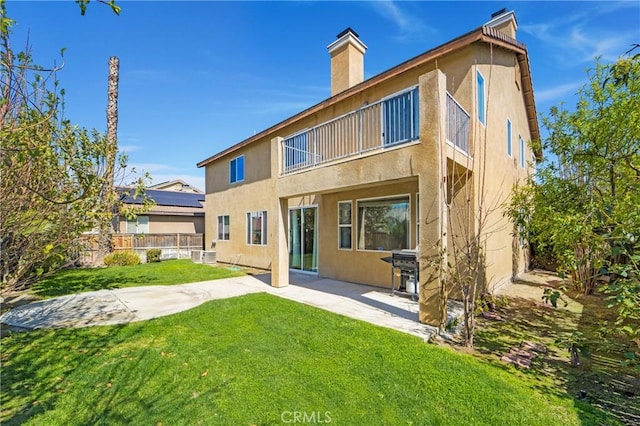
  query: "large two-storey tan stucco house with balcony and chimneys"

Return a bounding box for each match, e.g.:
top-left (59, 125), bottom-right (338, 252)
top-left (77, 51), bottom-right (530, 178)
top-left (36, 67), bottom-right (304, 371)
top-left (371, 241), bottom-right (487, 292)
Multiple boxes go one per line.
top-left (198, 11), bottom-right (541, 324)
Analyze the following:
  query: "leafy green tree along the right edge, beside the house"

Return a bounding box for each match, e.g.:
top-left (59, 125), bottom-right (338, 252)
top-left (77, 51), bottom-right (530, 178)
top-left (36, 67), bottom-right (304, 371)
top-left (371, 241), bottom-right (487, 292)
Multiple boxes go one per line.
top-left (508, 50), bottom-right (640, 338)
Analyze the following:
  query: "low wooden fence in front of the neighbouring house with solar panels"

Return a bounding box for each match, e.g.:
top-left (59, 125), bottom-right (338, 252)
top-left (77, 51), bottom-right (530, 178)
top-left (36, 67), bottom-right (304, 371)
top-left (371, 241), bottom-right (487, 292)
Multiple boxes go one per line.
top-left (80, 234), bottom-right (204, 265)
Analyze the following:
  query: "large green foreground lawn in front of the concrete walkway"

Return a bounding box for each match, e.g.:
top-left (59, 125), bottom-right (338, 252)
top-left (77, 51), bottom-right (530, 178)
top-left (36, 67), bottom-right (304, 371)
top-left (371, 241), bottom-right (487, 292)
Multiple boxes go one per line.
top-left (0, 293), bottom-right (607, 426)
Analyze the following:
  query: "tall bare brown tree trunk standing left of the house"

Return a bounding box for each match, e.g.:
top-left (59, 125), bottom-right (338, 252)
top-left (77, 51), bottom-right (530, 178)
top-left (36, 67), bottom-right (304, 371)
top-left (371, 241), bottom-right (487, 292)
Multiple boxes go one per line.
top-left (98, 56), bottom-right (120, 261)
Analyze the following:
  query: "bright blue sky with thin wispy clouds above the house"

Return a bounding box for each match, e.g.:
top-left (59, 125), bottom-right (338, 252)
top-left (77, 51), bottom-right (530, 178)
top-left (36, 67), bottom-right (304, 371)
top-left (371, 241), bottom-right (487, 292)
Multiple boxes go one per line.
top-left (7, 0), bottom-right (640, 189)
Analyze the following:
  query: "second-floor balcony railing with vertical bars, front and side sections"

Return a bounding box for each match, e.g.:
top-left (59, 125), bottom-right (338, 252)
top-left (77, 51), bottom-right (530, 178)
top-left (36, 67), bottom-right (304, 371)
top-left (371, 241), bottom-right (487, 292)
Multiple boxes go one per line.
top-left (281, 87), bottom-right (469, 174)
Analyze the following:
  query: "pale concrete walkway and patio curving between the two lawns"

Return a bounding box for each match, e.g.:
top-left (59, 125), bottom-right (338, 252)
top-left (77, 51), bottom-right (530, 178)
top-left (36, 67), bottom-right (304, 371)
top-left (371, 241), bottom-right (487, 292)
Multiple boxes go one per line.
top-left (0, 273), bottom-right (461, 340)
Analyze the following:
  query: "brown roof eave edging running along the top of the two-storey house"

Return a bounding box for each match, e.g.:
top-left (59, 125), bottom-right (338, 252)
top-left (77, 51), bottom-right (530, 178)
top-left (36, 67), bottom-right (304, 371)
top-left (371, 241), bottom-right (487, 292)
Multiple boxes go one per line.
top-left (196, 25), bottom-right (542, 168)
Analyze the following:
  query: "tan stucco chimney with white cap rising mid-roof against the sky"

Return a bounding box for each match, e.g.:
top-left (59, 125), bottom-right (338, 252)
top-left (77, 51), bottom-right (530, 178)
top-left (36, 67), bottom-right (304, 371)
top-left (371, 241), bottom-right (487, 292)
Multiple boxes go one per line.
top-left (327, 28), bottom-right (367, 96)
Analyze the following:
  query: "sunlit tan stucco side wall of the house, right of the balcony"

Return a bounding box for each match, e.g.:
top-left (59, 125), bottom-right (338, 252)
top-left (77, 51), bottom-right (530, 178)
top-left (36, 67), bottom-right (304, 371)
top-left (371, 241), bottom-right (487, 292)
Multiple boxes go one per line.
top-left (473, 45), bottom-right (533, 288)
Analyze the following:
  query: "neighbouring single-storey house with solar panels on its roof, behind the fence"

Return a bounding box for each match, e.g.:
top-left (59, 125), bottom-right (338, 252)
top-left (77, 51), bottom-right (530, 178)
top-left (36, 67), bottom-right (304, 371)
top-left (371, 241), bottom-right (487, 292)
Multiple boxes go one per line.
top-left (116, 184), bottom-right (205, 234)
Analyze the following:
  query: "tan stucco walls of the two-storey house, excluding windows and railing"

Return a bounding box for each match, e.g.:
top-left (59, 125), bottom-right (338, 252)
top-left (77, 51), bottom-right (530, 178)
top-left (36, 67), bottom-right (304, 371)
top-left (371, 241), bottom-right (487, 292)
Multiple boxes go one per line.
top-left (205, 40), bottom-right (532, 322)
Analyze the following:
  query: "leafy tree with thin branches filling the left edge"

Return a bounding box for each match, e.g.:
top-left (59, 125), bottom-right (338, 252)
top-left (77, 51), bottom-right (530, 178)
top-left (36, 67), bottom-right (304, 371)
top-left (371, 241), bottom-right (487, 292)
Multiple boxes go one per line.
top-left (0, 0), bottom-right (144, 293)
